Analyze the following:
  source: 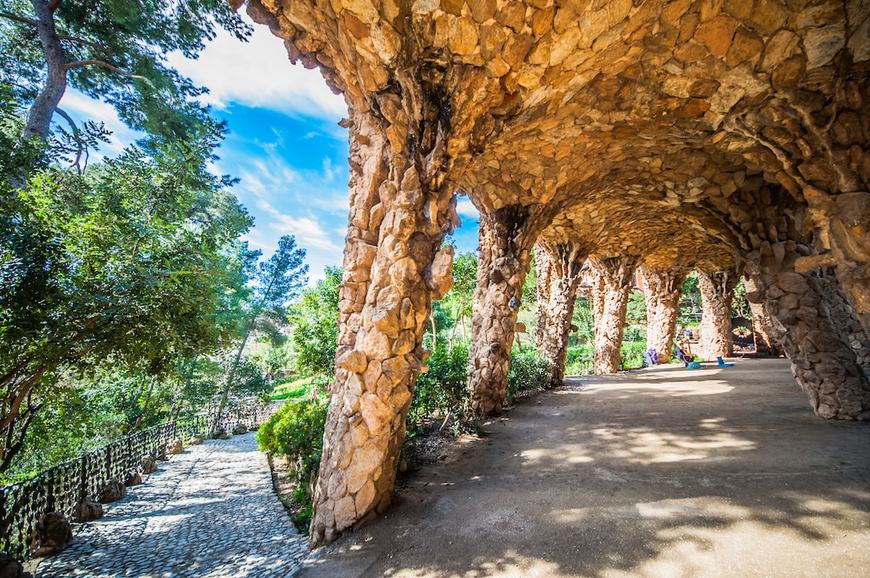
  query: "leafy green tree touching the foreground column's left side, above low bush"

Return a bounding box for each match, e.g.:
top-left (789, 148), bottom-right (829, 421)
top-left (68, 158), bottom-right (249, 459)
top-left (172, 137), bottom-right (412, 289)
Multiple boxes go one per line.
top-left (288, 267), bottom-right (342, 374)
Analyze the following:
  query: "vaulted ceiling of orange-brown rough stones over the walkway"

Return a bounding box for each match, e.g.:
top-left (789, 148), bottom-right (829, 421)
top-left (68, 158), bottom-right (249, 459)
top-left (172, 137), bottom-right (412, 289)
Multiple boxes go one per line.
top-left (249, 0), bottom-right (870, 282)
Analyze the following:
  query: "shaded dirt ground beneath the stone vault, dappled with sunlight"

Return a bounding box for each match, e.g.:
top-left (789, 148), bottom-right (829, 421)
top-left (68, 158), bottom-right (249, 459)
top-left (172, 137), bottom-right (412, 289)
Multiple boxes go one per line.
top-left (300, 359), bottom-right (870, 578)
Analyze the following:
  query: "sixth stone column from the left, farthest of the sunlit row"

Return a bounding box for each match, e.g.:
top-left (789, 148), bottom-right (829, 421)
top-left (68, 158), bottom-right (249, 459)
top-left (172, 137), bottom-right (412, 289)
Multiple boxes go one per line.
top-left (698, 271), bottom-right (738, 359)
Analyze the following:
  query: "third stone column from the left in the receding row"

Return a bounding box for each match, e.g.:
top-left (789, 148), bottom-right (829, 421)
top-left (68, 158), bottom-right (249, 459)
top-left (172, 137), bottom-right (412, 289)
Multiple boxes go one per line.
top-left (536, 242), bottom-right (587, 387)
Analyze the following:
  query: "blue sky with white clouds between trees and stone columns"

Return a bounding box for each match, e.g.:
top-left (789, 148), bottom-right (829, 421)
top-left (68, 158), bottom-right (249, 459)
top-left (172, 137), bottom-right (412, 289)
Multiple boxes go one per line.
top-left (61, 14), bottom-right (478, 282)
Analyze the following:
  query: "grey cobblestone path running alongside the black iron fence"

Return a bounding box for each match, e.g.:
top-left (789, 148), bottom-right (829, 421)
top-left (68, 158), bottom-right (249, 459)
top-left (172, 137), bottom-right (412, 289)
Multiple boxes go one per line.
top-left (36, 433), bottom-right (307, 578)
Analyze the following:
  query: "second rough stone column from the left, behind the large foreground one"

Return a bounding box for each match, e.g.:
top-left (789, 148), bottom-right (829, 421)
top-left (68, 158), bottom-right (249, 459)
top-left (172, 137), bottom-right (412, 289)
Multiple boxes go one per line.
top-left (468, 205), bottom-right (546, 417)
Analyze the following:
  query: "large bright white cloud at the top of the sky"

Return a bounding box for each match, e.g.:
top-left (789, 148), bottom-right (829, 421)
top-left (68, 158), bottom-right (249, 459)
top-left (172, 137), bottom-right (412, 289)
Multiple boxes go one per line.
top-left (168, 17), bottom-right (347, 120)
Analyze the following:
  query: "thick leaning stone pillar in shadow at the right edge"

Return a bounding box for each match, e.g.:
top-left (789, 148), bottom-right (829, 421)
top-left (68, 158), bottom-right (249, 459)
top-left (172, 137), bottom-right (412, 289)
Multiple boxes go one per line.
top-left (739, 187), bottom-right (870, 419)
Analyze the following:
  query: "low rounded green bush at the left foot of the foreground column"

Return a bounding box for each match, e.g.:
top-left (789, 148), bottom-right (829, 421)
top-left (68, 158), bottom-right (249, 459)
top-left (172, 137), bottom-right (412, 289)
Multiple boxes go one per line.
top-left (257, 400), bottom-right (326, 486)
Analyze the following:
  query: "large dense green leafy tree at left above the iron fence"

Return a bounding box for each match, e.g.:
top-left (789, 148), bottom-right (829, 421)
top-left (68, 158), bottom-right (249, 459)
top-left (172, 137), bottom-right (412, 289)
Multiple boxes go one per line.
top-left (0, 126), bottom-right (251, 471)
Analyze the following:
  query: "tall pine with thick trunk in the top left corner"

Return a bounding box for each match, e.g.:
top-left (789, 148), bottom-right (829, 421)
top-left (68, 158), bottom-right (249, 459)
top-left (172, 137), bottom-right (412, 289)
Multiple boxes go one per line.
top-left (0, 0), bottom-right (251, 146)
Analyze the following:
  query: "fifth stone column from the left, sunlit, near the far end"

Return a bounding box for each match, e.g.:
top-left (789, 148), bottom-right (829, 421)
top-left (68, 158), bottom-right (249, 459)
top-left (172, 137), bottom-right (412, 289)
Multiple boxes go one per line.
top-left (641, 267), bottom-right (686, 363)
